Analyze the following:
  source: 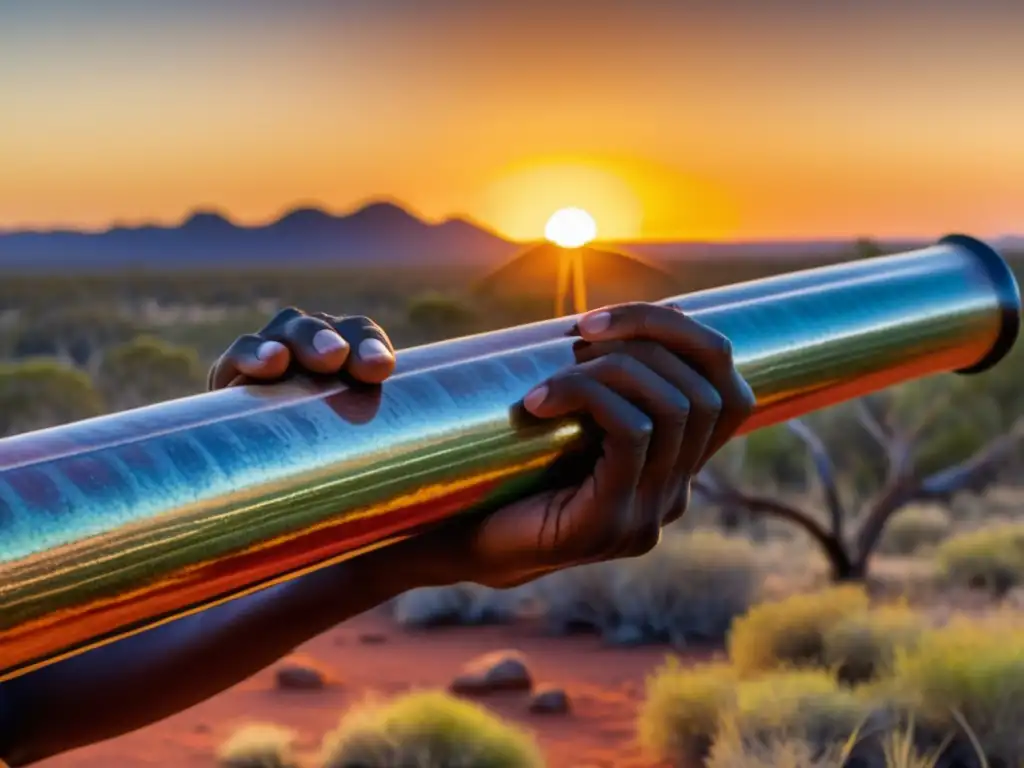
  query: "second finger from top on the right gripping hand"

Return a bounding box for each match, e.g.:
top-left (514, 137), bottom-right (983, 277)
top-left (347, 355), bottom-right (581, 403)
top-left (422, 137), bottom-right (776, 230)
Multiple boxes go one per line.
top-left (573, 341), bottom-right (722, 477)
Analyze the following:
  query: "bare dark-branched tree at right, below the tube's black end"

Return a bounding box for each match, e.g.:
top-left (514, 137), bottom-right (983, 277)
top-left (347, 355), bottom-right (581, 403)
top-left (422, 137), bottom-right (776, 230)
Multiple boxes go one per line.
top-left (695, 390), bottom-right (1024, 582)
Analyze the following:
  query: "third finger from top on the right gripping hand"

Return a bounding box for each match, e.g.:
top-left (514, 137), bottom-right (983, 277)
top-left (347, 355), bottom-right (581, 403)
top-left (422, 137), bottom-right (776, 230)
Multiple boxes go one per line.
top-left (561, 352), bottom-right (690, 510)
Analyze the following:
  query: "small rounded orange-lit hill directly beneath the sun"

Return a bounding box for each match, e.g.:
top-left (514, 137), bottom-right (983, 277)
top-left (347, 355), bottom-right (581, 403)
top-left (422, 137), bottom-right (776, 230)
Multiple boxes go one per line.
top-left (476, 243), bottom-right (679, 306)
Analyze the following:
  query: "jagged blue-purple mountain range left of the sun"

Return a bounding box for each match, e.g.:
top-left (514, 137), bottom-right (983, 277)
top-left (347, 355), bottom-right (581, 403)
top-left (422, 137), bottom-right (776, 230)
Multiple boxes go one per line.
top-left (0, 203), bottom-right (519, 270)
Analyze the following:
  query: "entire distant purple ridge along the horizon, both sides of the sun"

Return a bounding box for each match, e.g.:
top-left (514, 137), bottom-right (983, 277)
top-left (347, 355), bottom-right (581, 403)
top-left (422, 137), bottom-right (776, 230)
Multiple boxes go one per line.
top-left (0, 201), bottom-right (1024, 271)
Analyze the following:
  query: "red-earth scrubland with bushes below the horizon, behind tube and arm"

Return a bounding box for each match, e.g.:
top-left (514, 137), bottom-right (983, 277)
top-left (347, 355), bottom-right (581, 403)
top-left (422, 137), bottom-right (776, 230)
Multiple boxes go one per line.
top-left (6, 207), bottom-right (1024, 768)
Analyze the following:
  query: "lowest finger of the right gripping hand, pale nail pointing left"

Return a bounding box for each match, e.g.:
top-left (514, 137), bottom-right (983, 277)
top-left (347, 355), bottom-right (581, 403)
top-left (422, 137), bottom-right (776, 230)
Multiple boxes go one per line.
top-left (523, 370), bottom-right (653, 554)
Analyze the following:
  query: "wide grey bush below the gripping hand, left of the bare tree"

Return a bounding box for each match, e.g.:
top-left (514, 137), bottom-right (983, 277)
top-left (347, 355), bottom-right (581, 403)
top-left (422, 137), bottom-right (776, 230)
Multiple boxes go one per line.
top-left (536, 530), bottom-right (762, 646)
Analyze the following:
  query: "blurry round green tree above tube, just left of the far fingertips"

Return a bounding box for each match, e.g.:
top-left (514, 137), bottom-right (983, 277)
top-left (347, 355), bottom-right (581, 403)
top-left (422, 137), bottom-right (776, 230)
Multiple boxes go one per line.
top-left (97, 336), bottom-right (205, 411)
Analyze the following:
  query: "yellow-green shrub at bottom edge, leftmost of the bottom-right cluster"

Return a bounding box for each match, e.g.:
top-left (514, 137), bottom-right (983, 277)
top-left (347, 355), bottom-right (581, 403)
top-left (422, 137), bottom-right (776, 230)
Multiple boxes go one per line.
top-left (638, 659), bottom-right (737, 765)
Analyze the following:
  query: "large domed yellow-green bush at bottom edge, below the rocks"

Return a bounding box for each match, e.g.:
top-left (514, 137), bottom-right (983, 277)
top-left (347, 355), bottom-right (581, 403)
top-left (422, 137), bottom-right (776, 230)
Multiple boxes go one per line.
top-left (322, 691), bottom-right (544, 768)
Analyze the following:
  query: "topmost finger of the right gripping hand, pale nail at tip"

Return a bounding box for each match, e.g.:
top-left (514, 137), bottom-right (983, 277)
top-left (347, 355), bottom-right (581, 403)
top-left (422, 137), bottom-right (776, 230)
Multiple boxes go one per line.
top-left (578, 303), bottom-right (755, 469)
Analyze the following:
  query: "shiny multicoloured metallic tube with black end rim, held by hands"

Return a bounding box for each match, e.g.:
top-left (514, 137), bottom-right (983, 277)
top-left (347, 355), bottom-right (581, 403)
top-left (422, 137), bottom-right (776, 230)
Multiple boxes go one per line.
top-left (0, 236), bottom-right (1021, 680)
